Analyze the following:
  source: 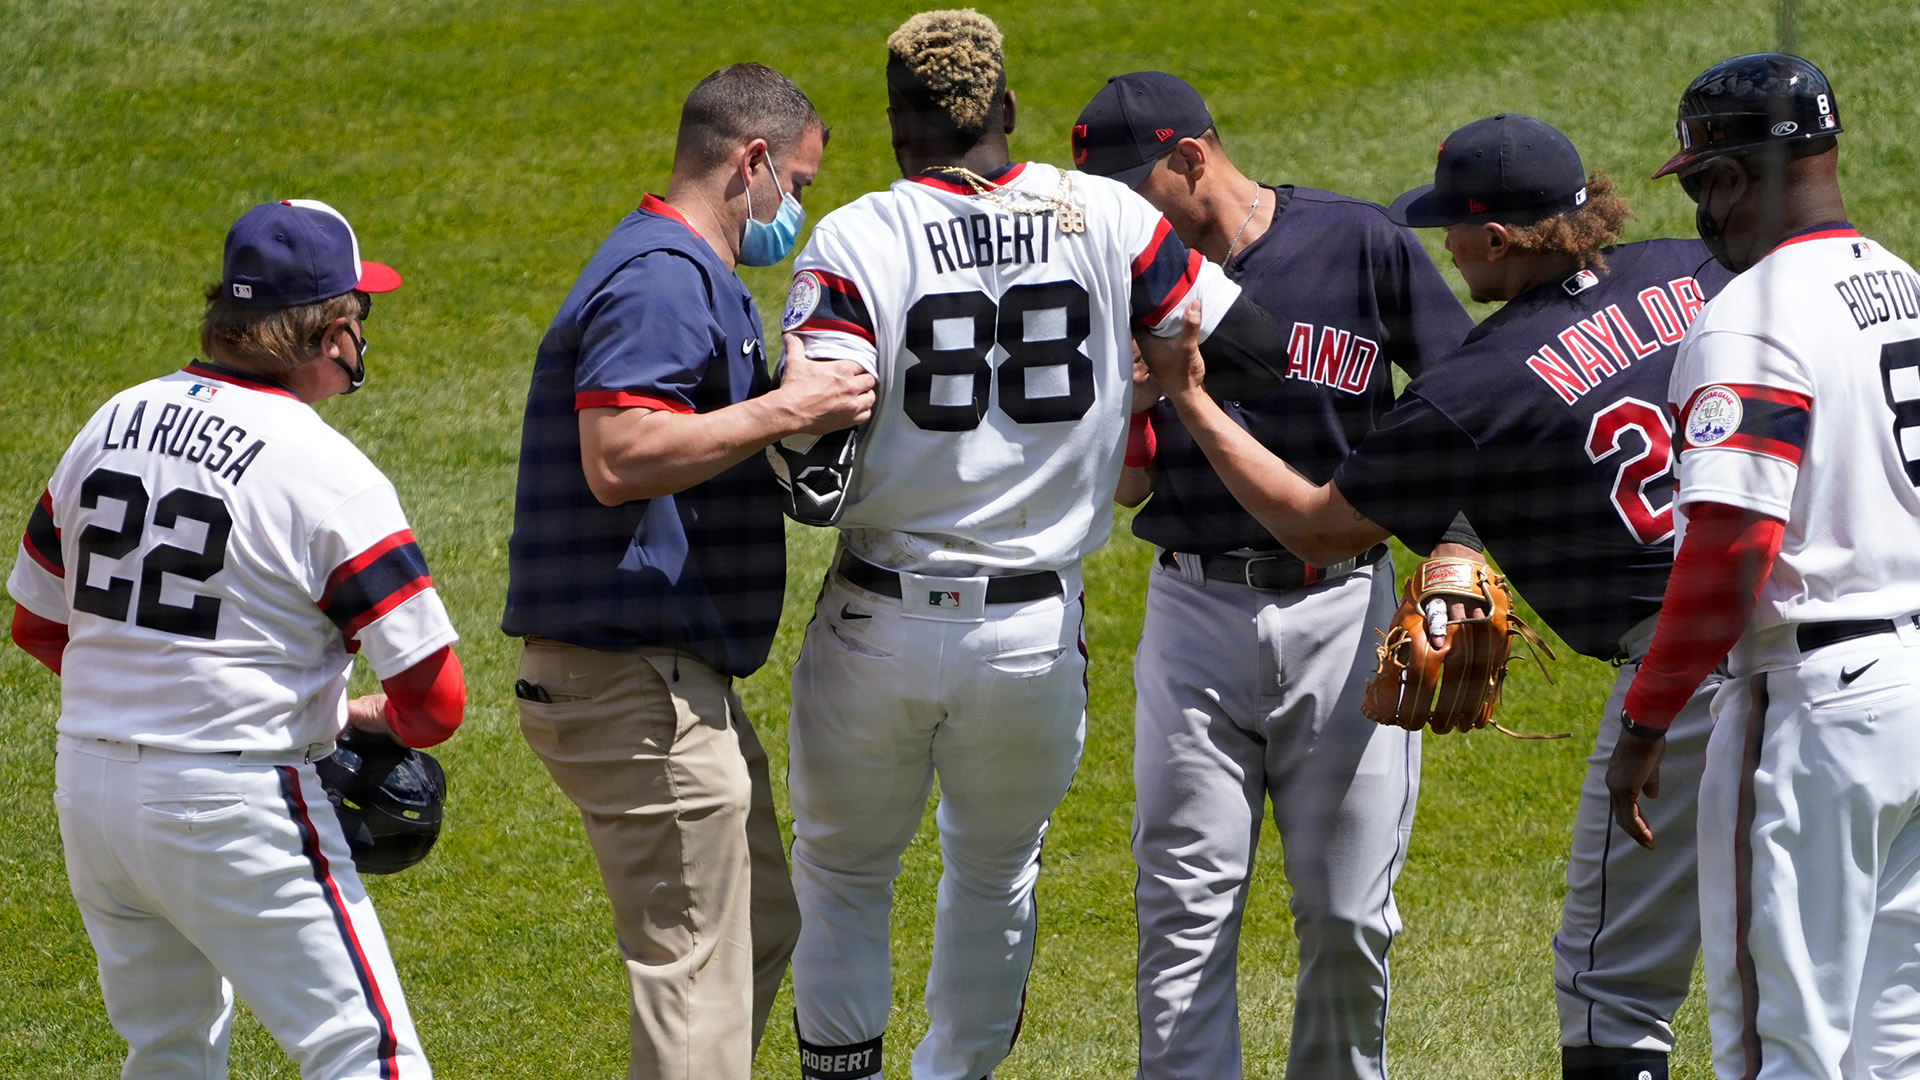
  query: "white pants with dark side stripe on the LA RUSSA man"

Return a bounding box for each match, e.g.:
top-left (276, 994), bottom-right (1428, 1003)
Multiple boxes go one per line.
top-left (54, 736), bottom-right (432, 1080)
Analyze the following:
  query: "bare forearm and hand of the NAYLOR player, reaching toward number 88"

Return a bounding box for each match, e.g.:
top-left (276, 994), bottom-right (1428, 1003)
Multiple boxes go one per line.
top-left (1169, 382), bottom-right (1386, 567)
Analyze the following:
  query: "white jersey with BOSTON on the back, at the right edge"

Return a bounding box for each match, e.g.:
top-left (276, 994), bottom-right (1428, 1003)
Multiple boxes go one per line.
top-left (1668, 227), bottom-right (1920, 673)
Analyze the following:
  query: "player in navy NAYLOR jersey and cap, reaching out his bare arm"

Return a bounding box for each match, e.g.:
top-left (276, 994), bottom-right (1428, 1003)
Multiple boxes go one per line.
top-left (1142, 113), bottom-right (1726, 1080)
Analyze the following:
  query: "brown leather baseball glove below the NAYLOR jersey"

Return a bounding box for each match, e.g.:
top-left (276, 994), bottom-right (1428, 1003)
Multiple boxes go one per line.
top-left (1359, 559), bottom-right (1569, 738)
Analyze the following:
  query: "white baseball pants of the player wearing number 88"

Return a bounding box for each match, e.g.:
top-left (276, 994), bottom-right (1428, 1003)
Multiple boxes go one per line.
top-left (787, 567), bottom-right (1087, 1080)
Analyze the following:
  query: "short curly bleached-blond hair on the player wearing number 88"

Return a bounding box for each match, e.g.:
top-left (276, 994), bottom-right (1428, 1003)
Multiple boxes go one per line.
top-left (887, 8), bottom-right (1006, 136)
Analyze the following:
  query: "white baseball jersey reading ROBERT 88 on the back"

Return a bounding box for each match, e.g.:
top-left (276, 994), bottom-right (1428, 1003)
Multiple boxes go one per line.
top-left (781, 163), bottom-right (1240, 575)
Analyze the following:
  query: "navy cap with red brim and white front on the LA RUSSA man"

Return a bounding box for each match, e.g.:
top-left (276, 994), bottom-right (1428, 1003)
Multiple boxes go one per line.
top-left (221, 198), bottom-right (399, 309)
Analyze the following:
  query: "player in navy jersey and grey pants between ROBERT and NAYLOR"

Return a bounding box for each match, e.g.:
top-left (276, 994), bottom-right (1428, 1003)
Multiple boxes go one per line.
top-left (1073, 71), bottom-right (1478, 1078)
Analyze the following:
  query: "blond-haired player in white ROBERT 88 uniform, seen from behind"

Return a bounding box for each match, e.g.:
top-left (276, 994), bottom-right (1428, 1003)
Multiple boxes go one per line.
top-left (781, 12), bottom-right (1281, 1080)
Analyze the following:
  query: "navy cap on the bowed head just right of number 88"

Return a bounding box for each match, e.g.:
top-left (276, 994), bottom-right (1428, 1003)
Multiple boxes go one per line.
top-left (1073, 71), bottom-right (1213, 188)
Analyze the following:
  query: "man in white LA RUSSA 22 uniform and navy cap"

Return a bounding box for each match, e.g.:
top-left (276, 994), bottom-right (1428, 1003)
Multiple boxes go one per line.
top-left (8, 200), bottom-right (465, 1078)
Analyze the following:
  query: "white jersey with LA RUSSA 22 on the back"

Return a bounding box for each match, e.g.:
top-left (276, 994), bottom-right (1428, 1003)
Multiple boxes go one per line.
top-left (8, 363), bottom-right (457, 751)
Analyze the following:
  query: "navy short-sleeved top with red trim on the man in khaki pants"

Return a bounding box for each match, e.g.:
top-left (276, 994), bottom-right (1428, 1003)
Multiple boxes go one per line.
top-left (501, 196), bottom-right (787, 676)
